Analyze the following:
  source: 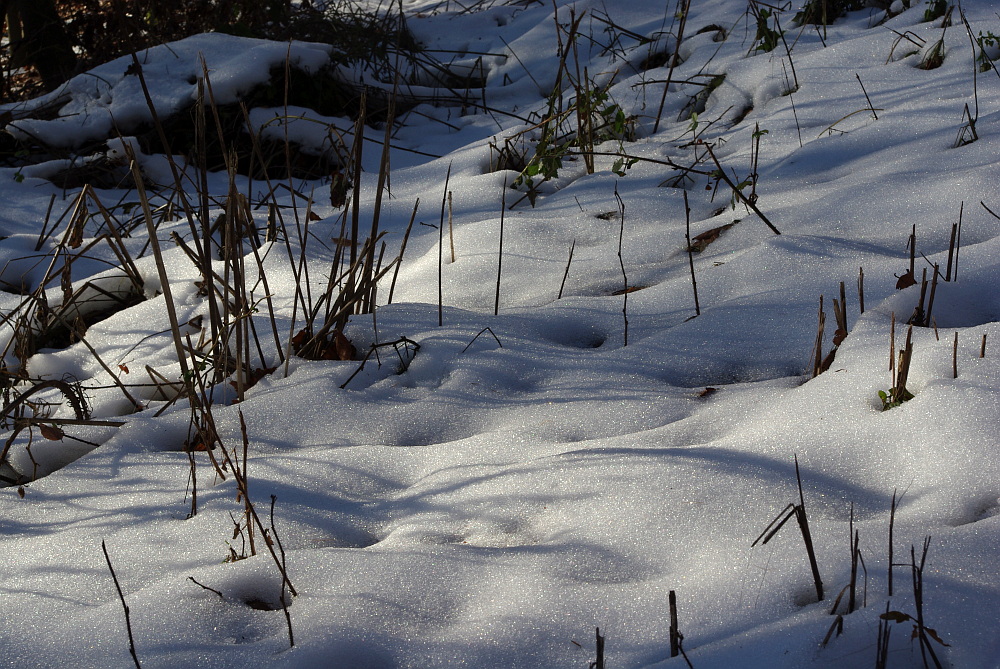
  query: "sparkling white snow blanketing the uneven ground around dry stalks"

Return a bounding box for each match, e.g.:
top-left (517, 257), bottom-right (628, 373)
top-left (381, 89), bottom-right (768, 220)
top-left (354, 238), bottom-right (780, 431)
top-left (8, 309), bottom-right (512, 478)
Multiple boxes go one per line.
top-left (0, 0), bottom-right (1000, 669)
